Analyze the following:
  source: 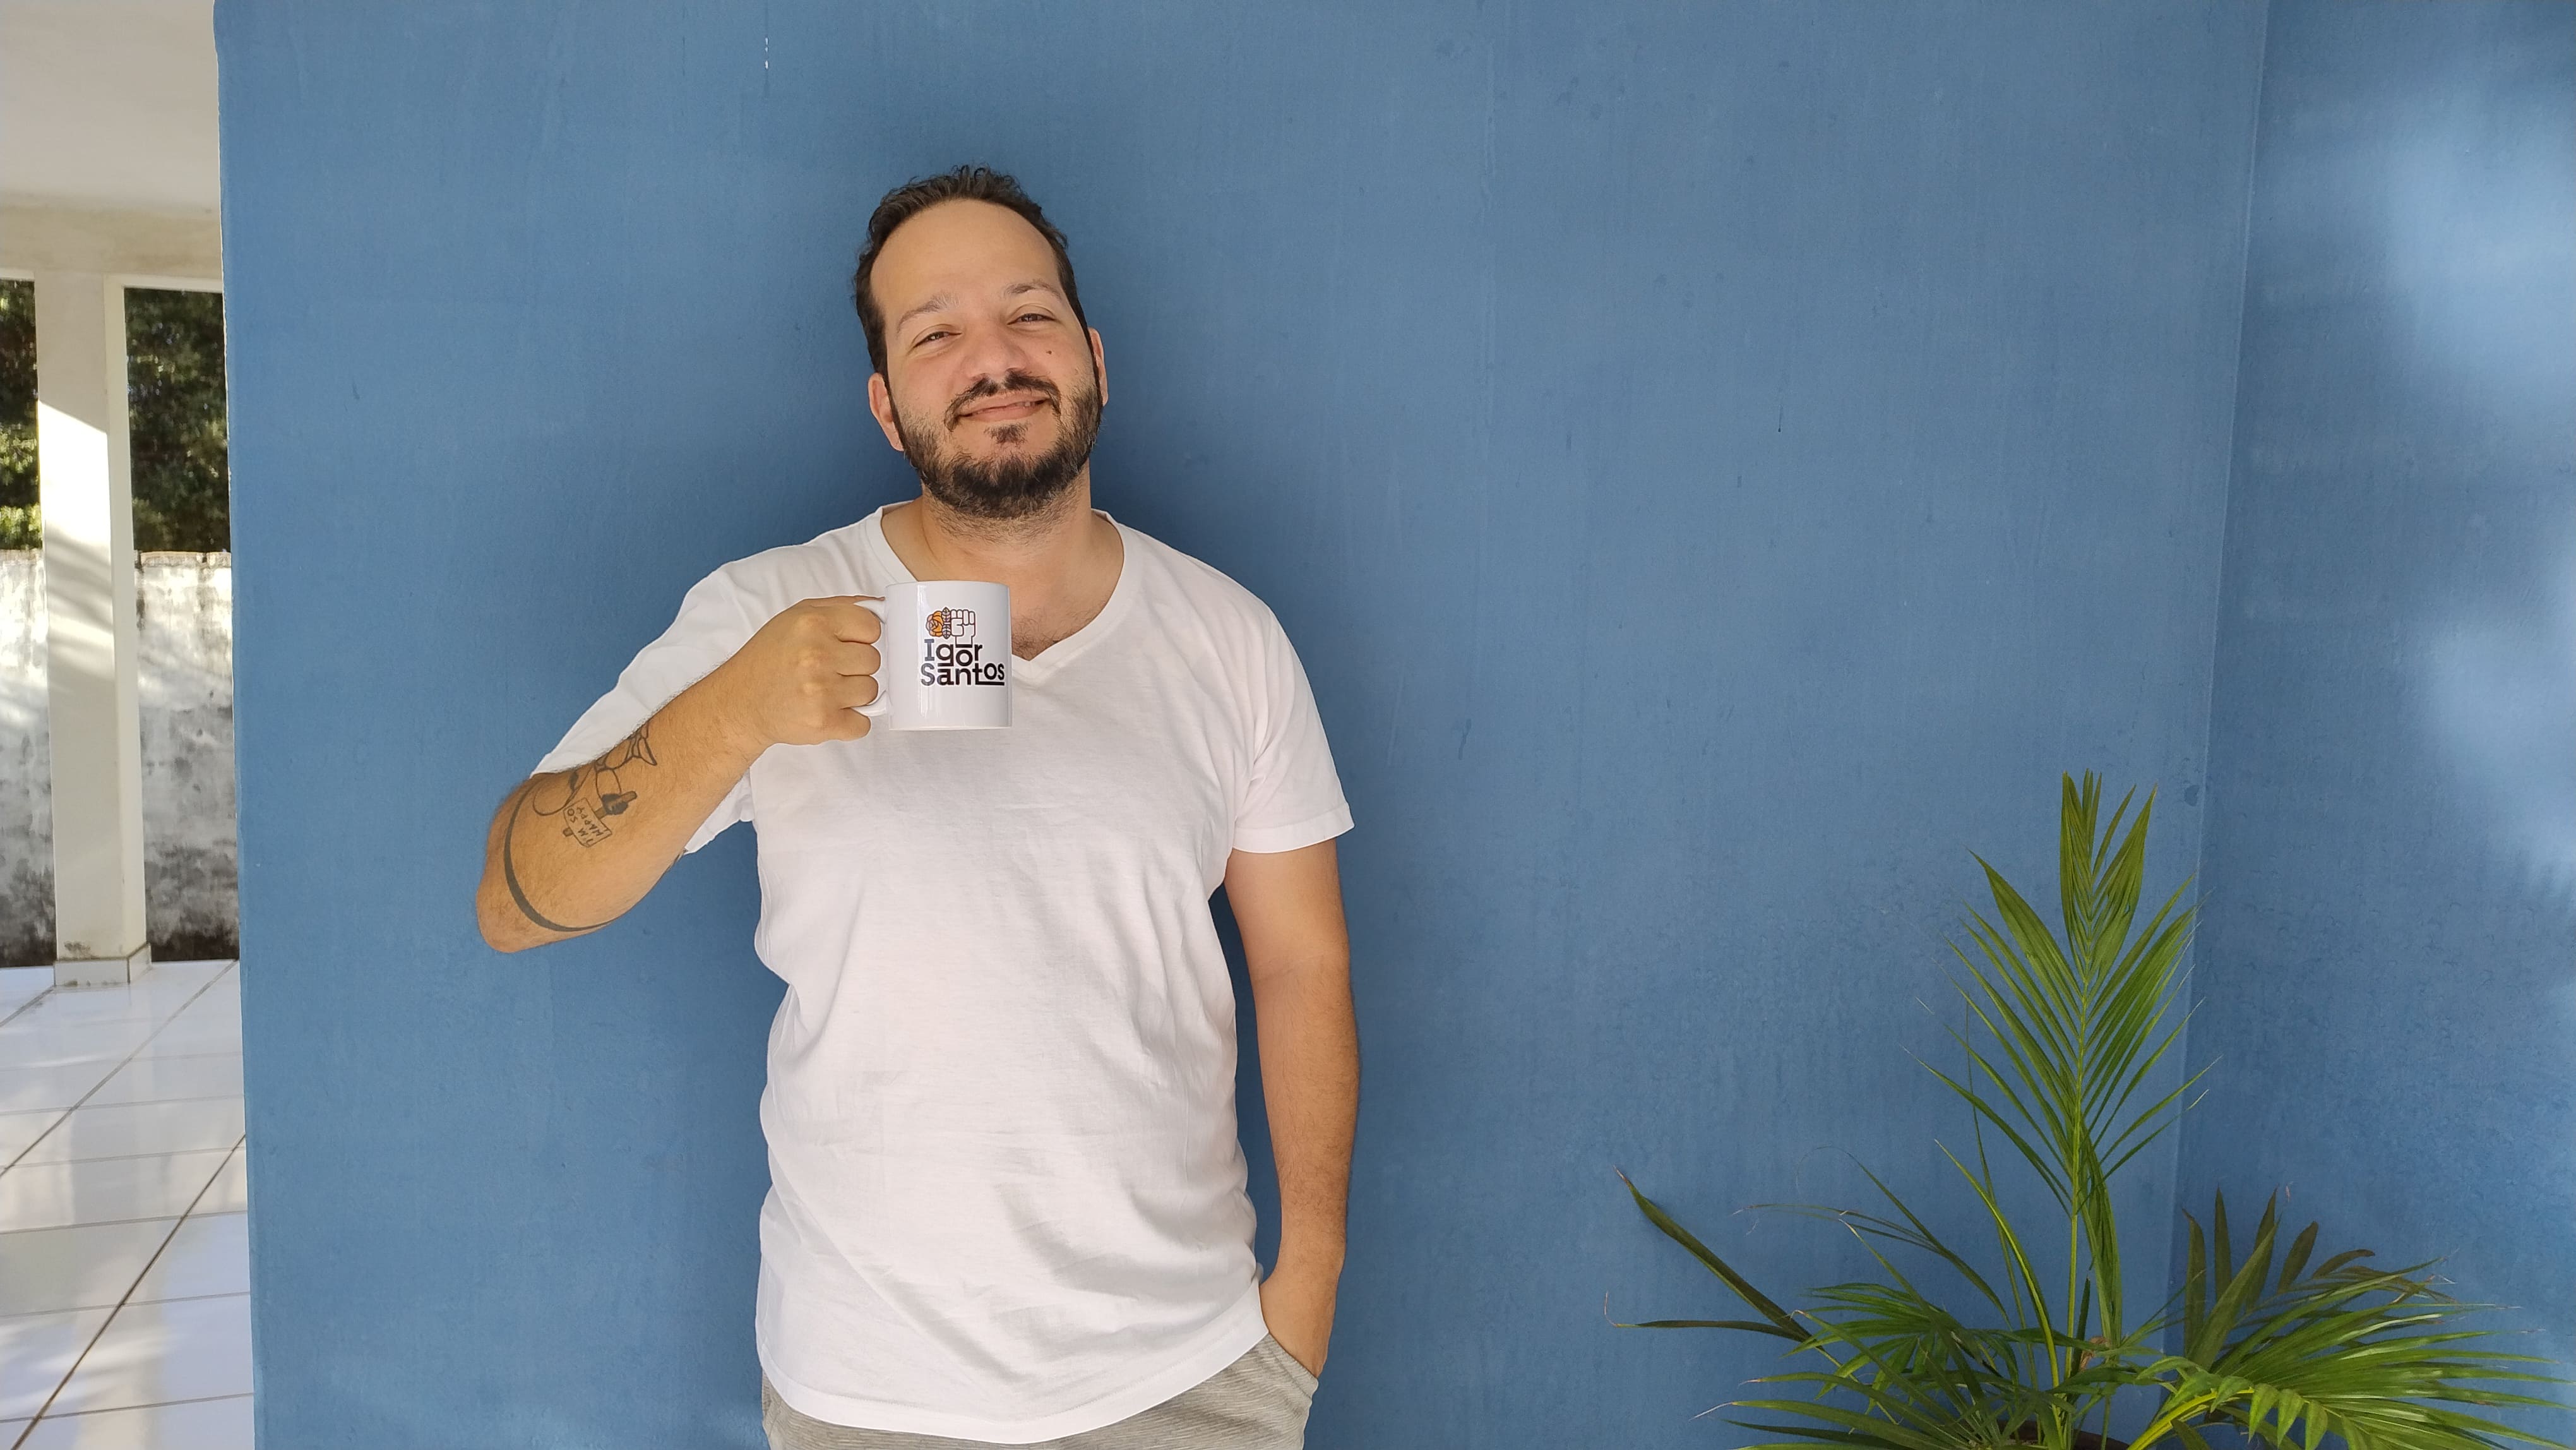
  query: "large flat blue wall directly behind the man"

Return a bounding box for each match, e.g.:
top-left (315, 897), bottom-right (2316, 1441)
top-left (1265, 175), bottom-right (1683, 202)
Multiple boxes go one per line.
top-left (219, 0), bottom-right (2262, 1450)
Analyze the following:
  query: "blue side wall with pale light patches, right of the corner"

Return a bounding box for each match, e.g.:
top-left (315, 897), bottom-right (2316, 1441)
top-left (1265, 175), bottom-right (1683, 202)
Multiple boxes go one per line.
top-left (2182, 0), bottom-right (2576, 1411)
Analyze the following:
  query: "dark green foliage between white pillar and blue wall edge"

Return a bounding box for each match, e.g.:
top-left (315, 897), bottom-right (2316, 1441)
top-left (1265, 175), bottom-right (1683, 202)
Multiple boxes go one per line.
top-left (126, 289), bottom-right (232, 554)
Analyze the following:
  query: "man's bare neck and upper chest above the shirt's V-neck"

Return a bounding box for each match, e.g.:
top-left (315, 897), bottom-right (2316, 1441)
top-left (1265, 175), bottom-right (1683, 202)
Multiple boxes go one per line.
top-left (883, 466), bottom-right (1126, 659)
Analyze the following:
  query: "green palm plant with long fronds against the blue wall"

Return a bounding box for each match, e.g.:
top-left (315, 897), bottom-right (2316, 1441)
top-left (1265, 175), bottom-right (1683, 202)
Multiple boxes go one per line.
top-left (1620, 772), bottom-right (2561, 1450)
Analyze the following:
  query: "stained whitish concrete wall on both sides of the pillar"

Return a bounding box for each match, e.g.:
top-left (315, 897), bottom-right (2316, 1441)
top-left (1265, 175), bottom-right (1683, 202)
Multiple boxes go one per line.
top-left (0, 549), bottom-right (237, 966)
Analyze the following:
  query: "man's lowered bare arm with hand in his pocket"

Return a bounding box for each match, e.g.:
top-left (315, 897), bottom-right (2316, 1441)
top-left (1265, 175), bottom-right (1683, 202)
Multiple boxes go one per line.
top-left (1226, 839), bottom-right (1360, 1370)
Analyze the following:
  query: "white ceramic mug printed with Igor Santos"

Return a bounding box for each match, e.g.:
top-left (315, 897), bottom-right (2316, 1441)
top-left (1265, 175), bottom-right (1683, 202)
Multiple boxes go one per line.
top-left (858, 580), bottom-right (1010, 729)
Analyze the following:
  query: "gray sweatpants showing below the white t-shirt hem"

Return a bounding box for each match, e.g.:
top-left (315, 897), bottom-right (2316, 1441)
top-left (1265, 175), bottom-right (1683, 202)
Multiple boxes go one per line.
top-left (760, 1334), bottom-right (1314, 1450)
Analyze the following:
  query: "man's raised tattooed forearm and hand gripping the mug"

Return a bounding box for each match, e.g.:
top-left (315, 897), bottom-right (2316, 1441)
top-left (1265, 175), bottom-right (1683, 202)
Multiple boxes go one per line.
top-left (474, 597), bottom-right (878, 950)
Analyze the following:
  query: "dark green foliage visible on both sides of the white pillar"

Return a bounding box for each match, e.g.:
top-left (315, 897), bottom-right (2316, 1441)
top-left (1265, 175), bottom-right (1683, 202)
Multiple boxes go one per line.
top-left (0, 281), bottom-right (232, 551)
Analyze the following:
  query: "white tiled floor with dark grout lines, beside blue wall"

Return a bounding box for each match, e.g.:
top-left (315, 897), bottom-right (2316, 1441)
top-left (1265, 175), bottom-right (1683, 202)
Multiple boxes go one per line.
top-left (0, 961), bottom-right (250, 1450)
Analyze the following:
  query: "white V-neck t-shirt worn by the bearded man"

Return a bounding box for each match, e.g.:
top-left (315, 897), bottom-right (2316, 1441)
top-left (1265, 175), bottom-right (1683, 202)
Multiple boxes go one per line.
top-left (539, 513), bottom-right (1350, 1445)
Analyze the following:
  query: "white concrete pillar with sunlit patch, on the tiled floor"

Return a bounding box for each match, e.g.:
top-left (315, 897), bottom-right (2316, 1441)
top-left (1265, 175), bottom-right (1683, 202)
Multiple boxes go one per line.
top-left (36, 270), bottom-right (152, 986)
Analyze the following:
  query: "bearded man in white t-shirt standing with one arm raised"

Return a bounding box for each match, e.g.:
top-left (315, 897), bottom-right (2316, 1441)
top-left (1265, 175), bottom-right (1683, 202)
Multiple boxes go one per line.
top-left (477, 167), bottom-right (1360, 1450)
